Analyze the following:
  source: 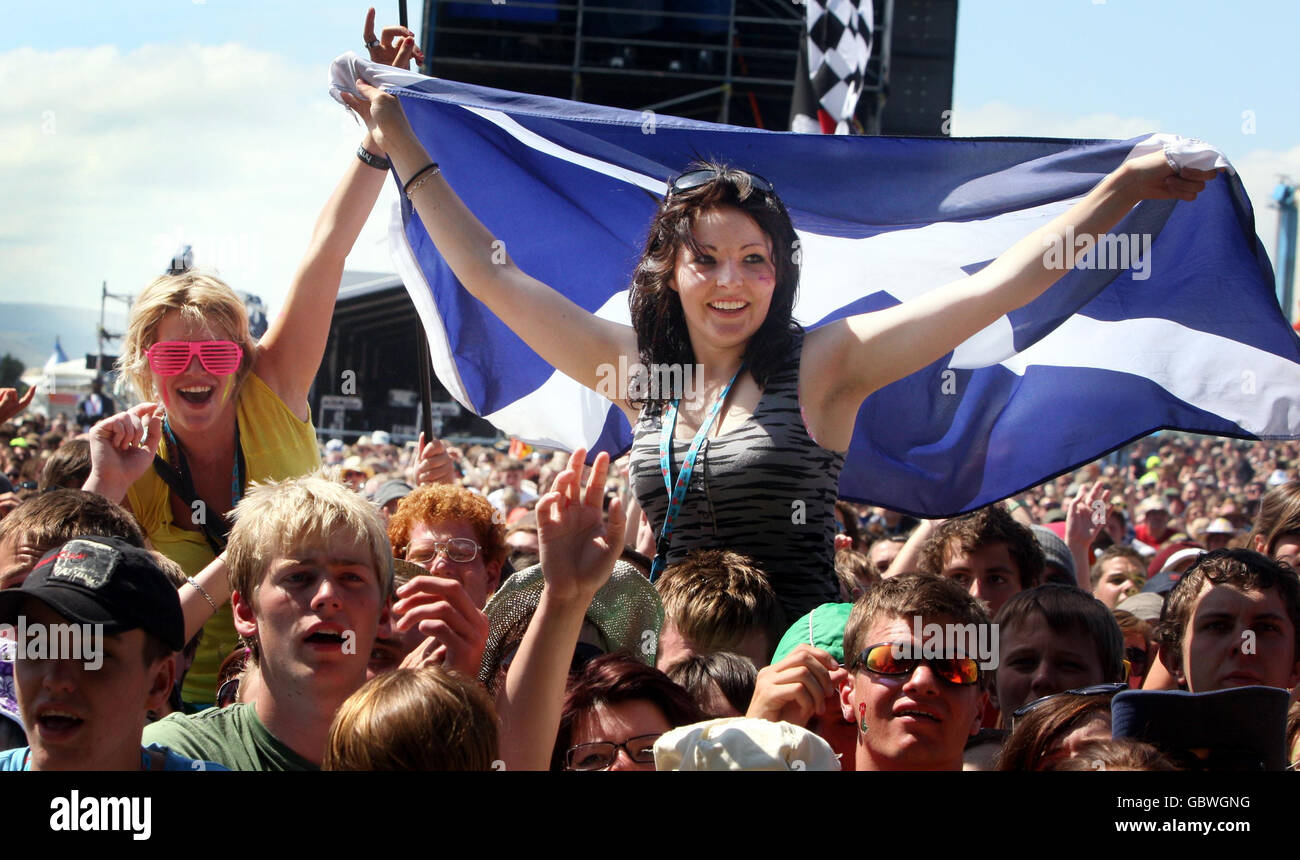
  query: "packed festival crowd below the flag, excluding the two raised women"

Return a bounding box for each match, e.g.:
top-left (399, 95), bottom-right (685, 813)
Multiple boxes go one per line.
top-left (0, 381), bottom-right (1300, 770)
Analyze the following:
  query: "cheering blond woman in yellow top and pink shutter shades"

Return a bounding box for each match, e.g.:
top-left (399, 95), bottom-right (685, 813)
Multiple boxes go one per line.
top-left (85, 11), bottom-right (416, 703)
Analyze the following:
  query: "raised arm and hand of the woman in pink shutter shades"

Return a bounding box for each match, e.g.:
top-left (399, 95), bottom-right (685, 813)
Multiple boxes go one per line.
top-left (256, 9), bottom-right (419, 421)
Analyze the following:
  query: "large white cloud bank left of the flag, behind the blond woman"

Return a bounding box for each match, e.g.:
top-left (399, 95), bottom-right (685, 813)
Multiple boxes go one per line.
top-left (0, 44), bottom-right (395, 310)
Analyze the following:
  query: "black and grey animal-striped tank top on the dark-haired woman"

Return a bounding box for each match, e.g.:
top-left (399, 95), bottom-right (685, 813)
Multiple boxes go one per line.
top-left (632, 340), bottom-right (844, 621)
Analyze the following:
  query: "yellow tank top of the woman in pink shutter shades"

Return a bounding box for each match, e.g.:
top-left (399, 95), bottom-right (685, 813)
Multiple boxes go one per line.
top-left (126, 373), bottom-right (320, 704)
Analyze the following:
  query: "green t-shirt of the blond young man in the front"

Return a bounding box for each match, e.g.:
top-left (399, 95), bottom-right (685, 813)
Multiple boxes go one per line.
top-left (144, 703), bottom-right (320, 770)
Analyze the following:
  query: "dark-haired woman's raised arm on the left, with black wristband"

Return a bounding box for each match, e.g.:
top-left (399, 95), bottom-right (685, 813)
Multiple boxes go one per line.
top-left (343, 81), bottom-right (637, 408)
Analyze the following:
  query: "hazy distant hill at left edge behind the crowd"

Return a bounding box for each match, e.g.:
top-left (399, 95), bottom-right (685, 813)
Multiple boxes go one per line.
top-left (0, 301), bottom-right (126, 368)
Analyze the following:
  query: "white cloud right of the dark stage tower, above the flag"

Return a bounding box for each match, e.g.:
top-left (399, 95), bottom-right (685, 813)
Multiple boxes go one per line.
top-left (952, 101), bottom-right (1300, 316)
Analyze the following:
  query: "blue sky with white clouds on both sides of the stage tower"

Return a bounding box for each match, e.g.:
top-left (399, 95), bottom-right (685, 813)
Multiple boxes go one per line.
top-left (0, 0), bottom-right (1300, 324)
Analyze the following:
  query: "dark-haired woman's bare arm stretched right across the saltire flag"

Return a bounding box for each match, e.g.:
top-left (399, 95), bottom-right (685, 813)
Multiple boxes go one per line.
top-left (801, 152), bottom-right (1217, 449)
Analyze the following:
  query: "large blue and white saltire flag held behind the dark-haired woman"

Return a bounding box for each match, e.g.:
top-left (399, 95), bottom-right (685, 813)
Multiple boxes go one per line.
top-left (334, 56), bottom-right (1300, 517)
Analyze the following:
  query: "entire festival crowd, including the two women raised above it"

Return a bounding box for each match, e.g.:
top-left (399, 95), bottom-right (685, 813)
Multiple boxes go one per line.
top-left (0, 10), bottom-right (1300, 770)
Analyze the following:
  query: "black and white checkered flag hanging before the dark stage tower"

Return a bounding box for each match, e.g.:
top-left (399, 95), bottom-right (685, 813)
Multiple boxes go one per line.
top-left (790, 0), bottom-right (874, 134)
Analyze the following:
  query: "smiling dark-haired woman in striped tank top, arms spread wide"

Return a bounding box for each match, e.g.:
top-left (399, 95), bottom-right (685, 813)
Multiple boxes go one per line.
top-left (343, 81), bottom-right (1214, 618)
